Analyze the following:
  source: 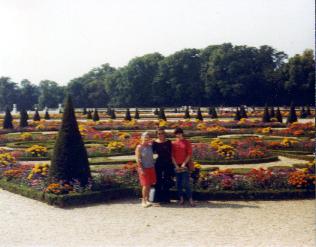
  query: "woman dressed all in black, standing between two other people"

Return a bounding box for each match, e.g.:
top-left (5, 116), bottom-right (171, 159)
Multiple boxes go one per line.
top-left (152, 128), bottom-right (174, 203)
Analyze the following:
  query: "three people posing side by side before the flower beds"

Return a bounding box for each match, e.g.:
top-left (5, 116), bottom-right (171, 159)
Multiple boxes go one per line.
top-left (135, 128), bottom-right (195, 207)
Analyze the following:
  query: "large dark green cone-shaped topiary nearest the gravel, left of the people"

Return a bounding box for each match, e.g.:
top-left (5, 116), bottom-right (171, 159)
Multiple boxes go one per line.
top-left (49, 96), bottom-right (91, 185)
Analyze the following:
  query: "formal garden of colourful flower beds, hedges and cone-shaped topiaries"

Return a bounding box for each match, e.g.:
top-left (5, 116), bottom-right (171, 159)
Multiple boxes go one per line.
top-left (0, 97), bottom-right (315, 207)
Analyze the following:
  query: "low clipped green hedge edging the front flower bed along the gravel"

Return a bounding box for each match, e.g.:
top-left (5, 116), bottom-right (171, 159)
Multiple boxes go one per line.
top-left (0, 179), bottom-right (315, 208)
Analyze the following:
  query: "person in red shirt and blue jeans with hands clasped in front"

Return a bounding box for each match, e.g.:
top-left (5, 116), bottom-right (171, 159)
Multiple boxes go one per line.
top-left (172, 128), bottom-right (195, 207)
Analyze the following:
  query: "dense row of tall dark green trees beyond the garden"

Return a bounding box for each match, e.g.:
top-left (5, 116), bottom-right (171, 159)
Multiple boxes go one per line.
top-left (0, 43), bottom-right (315, 109)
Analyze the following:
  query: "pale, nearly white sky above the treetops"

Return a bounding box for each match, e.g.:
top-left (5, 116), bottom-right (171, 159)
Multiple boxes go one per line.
top-left (0, 0), bottom-right (315, 85)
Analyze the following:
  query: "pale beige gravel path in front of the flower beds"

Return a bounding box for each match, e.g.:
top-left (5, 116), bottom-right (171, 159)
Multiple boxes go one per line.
top-left (0, 190), bottom-right (315, 247)
